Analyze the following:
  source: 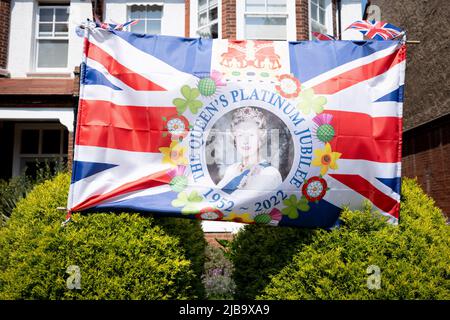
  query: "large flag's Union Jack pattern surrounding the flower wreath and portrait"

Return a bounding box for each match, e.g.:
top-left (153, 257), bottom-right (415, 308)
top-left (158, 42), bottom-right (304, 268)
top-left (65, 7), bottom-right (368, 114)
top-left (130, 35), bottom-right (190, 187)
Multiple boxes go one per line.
top-left (67, 28), bottom-right (405, 227)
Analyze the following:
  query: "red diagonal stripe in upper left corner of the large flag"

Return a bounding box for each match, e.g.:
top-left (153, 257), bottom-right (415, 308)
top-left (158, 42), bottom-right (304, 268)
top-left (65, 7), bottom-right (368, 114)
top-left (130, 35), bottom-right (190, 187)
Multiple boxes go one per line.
top-left (86, 42), bottom-right (166, 91)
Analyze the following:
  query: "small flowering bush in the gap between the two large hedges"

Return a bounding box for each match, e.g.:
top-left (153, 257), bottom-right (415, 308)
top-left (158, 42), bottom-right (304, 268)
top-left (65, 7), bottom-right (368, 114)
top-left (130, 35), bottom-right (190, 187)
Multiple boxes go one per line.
top-left (202, 246), bottom-right (236, 300)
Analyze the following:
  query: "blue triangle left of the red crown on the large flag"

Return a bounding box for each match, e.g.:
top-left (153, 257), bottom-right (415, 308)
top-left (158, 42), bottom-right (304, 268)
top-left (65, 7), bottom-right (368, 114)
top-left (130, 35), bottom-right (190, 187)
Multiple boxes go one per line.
top-left (111, 31), bottom-right (213, 78)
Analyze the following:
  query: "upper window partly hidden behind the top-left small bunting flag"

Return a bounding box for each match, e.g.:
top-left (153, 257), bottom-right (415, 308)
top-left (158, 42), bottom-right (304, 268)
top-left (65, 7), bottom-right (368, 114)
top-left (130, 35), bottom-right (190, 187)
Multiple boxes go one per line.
top-left (129, 5), bottom-right (163, 34)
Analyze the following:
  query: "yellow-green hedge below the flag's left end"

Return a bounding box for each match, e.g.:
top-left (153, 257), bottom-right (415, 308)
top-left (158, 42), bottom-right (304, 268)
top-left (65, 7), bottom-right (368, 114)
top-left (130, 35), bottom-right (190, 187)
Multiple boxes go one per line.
top-left (0, 174), bottom-right (203, 299)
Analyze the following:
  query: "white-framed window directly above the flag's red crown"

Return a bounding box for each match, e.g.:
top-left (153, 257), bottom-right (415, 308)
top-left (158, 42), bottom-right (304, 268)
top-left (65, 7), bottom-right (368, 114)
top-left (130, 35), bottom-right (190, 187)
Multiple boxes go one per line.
top-left (244, 0), bottom-right (288, 40)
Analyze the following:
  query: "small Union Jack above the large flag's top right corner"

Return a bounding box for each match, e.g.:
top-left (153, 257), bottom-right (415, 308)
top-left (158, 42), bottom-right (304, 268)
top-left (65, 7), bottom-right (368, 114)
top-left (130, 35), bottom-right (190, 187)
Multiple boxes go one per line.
top-left (346, 20), bottom-right (402, 40)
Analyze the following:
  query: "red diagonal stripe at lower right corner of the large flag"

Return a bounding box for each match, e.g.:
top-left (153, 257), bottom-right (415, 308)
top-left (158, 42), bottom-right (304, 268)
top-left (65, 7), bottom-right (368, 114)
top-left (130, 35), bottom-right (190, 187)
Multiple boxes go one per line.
top-left (330, 173), bottom-right (400, 218)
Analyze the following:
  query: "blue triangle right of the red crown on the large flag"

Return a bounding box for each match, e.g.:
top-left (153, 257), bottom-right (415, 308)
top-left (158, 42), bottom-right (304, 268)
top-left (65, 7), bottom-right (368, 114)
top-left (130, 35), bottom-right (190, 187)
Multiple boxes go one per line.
top-left (289, 40), bottom-right (398, 82)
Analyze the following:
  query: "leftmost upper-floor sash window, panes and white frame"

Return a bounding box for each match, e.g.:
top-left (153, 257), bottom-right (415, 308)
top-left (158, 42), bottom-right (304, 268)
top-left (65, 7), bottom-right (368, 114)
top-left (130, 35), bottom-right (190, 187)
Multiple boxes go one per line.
top-left (35, 6), bottom-right (69, 69)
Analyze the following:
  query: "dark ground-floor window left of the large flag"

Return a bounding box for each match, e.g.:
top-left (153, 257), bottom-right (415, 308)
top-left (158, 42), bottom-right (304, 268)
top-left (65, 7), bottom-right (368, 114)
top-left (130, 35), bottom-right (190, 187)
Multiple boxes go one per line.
top-left (13, 123), bottom-right (68, 176)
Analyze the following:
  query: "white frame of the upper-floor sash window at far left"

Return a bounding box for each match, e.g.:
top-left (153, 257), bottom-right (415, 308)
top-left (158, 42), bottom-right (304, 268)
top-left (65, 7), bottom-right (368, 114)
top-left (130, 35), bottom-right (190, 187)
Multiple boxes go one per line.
top-left (33, 3), bottom-right (70, 73)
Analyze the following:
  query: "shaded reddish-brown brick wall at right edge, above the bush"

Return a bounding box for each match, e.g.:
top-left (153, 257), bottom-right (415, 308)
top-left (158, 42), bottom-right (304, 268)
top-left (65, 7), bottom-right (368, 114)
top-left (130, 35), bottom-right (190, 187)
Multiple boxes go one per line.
top-left (402, 115), bottom-right (450, 216)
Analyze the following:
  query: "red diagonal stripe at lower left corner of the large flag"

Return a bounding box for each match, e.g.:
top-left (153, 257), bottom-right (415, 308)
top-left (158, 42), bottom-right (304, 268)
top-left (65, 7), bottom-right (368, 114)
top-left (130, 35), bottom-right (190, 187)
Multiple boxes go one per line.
top-left (70, 169), bottom-right (172, 212)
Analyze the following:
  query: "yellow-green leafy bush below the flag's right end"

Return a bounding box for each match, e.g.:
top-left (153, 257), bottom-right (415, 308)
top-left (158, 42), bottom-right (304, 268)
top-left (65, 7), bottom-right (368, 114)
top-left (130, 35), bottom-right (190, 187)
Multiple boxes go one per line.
top-left (259, 178), bottom-right (450, 299)
